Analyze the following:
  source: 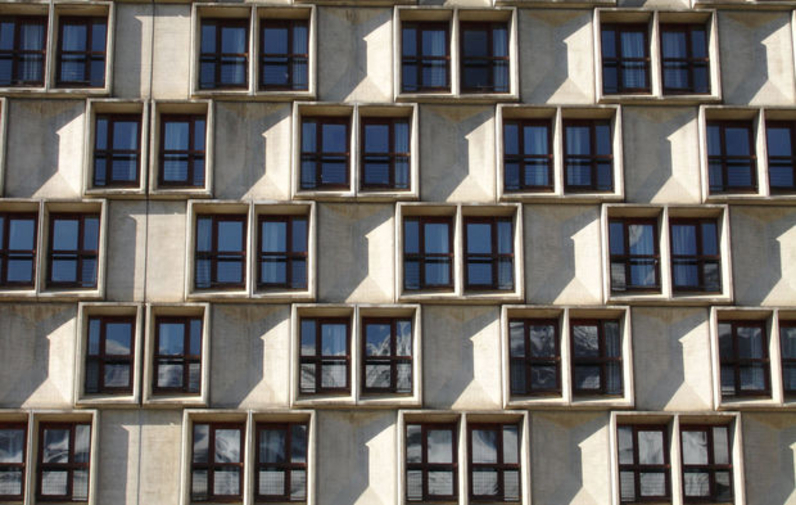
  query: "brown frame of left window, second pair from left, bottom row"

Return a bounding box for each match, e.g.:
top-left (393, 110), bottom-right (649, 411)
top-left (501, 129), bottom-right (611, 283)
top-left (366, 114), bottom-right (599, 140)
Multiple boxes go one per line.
top-left (189, 421), bottom-right (246, 503)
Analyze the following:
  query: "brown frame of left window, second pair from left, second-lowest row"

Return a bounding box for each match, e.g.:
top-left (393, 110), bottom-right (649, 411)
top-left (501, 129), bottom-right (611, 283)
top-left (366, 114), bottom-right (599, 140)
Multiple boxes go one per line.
top-left (299, 316), bottom-right (351, 396)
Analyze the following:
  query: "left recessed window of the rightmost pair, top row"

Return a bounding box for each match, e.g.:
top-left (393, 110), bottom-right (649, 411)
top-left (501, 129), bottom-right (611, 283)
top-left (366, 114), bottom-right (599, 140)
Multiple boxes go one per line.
top-left (601, 24), bottom-right (651, 94)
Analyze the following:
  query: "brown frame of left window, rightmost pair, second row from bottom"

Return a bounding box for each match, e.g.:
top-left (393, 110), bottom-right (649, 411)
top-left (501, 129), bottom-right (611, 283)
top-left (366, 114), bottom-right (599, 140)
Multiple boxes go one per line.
top-left (717, 319), bottom-right (771, 400)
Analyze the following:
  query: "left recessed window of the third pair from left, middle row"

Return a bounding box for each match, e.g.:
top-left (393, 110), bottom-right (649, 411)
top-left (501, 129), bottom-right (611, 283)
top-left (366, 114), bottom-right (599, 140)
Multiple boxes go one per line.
top-left (404, 217), bottom-right (453, 290)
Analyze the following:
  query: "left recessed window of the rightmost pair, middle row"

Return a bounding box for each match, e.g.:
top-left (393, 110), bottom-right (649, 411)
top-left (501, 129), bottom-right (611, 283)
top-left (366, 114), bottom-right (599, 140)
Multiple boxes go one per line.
top-left (609, 219), bottom-right (660, 293)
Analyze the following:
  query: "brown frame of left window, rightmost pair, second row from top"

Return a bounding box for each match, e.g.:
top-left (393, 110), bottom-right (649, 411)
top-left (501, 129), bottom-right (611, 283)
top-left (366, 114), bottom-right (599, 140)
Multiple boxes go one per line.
top-left (705, 119), bottom-right (757, 194)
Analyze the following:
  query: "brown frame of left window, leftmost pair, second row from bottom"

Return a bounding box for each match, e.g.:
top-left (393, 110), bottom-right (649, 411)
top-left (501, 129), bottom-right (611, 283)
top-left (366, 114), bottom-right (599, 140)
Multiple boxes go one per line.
top-left (83, 315), bottom-right (136, 395)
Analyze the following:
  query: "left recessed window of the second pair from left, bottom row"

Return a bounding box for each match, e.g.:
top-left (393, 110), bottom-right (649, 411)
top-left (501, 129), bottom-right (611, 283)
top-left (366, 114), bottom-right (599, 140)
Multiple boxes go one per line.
top-left (191, 422), bottom-right (246, 502)
